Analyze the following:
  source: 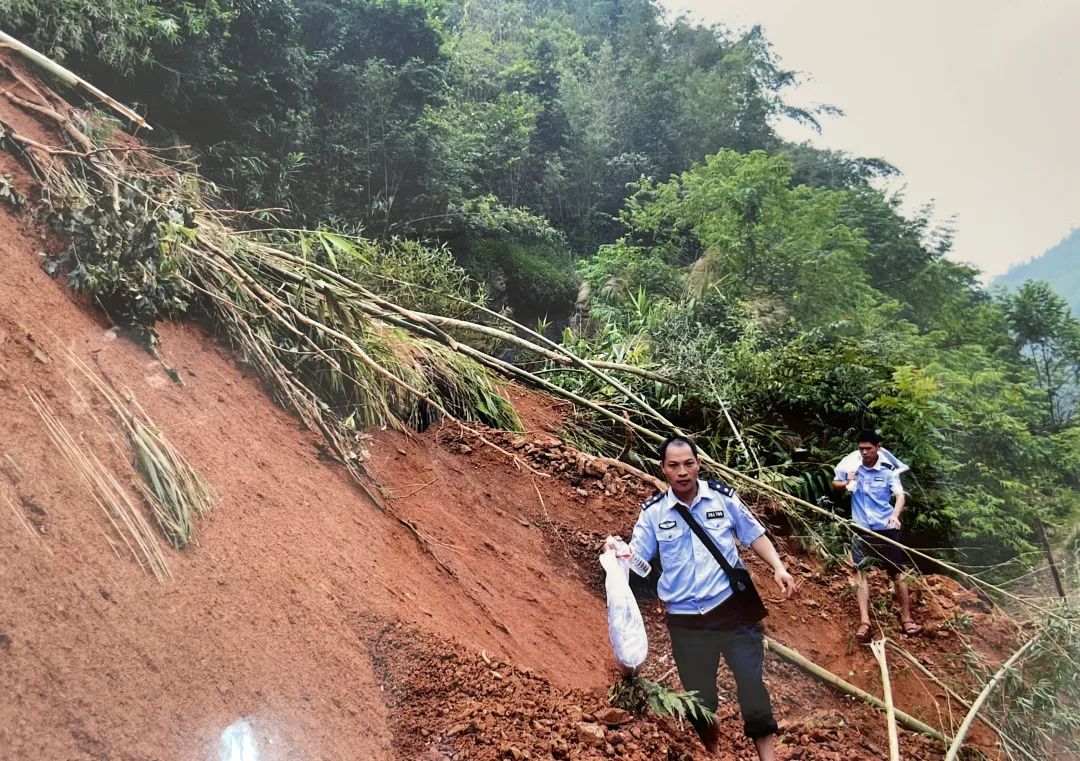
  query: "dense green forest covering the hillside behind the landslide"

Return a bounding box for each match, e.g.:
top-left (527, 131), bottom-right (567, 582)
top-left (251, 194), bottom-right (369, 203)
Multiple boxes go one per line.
top-left (0, 0), bottom-right (1080, 576)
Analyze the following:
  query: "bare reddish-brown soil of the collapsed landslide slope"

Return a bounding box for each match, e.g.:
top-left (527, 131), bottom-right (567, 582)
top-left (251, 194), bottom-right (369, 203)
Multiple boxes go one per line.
top-left (0, 55), bottom-right (1009, 759)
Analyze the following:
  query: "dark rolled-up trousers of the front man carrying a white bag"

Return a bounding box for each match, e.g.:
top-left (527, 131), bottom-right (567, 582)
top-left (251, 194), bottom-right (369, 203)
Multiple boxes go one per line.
top-left (667, 624), bottom-right (777, 737)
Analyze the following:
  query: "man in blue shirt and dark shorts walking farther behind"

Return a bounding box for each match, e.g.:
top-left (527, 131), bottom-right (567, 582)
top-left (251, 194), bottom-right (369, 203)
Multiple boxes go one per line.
top-left (833, 431), bottom-right (922, 643)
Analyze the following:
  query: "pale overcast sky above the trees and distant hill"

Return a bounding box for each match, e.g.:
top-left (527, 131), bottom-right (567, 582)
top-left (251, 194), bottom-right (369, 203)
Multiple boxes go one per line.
top-left (662, 0), bottom-right (1080, 276)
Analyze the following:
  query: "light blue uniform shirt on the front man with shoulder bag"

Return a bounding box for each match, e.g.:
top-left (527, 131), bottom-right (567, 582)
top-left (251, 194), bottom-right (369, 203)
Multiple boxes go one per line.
top-left (630, 480), bottom-right (765, 614)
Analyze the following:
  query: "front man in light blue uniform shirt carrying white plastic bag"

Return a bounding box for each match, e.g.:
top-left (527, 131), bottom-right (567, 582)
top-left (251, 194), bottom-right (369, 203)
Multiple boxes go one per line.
top-left (617, 436), bottom-right (795, 761)
